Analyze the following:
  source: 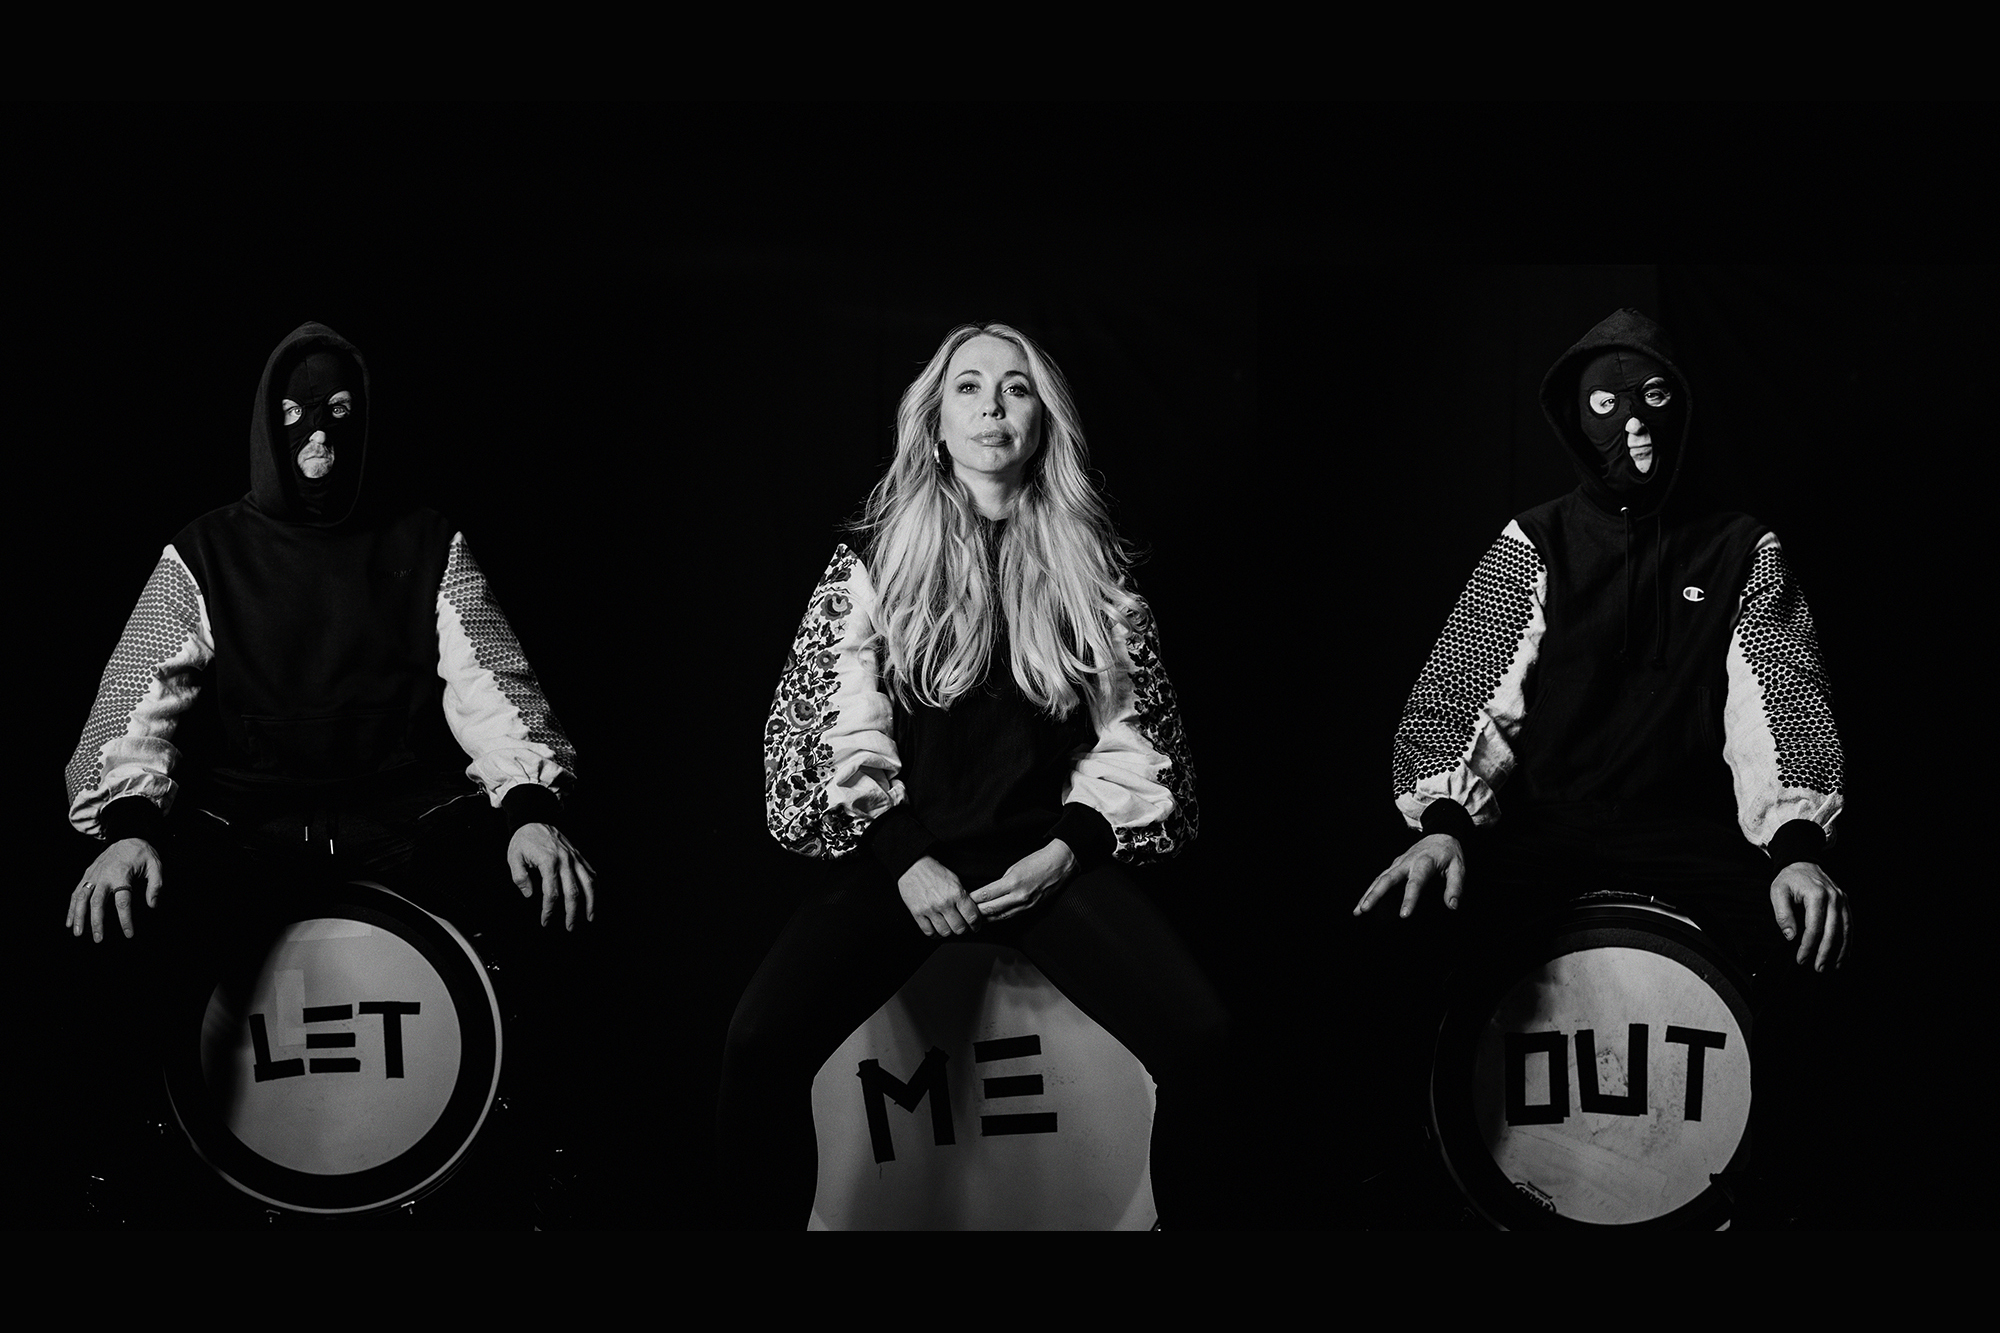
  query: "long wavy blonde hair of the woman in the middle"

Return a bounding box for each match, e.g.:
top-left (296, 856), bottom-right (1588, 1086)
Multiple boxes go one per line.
top-left (856, 324), bottom-right (1132, 717)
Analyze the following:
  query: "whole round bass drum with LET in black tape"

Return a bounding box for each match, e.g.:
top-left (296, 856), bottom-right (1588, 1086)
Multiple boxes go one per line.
top-left (166, 883), bottom-right (500, 1217)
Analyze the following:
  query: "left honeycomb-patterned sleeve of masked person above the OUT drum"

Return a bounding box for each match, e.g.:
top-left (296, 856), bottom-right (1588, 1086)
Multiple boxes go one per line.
top-left (1392, 522), bottom-right (1548, 829)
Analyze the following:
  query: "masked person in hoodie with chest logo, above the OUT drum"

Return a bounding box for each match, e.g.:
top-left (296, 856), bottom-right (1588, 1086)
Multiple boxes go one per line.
top-left (1358, 310), bottom-right (1842, 961)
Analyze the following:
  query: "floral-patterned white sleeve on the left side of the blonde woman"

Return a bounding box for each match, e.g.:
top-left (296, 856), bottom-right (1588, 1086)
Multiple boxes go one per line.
top-left (764, 546), bottom-right (906, 857)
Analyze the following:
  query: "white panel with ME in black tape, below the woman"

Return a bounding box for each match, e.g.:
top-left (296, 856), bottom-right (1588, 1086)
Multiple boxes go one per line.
top-left (808, 943), bottom-right (1156, 1231)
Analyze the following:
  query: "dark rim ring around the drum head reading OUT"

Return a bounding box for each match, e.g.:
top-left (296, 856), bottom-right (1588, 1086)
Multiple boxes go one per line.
top-left (1430, 895), bottom-right (1756, 1231)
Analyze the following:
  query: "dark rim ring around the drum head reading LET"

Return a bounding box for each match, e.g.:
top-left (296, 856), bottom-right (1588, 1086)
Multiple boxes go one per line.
top-left (164, 881), bottom-right (504, 1215)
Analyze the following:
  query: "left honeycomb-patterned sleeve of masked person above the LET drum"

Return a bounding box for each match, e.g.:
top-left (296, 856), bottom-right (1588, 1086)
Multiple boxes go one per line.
top-left (64, 546), bottom-right (216, 839)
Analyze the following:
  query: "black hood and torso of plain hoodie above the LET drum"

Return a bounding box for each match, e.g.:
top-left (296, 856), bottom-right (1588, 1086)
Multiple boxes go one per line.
top-left (174, 324), bottom-right (464, 809)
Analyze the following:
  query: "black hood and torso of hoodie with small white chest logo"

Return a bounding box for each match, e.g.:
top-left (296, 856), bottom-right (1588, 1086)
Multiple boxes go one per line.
top-left (1514, 310), bottom-right (1766, 815)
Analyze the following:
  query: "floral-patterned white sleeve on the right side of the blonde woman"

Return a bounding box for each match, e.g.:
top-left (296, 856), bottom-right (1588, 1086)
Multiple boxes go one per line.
top-left (1062, 592), bottom-right (1200, 865)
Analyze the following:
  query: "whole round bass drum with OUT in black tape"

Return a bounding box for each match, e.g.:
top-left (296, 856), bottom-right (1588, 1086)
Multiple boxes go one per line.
top-left (1430, 893), bottom-right (1750, 1229)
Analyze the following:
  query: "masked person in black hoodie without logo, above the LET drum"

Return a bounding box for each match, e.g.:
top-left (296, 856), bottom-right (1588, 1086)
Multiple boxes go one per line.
top-left (68, 324), bottom-right (592, 935)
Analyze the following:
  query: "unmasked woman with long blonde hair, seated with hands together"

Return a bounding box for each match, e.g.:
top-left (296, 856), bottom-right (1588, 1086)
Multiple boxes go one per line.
top-left (720, 324), bottom-right (1226, 1227)
